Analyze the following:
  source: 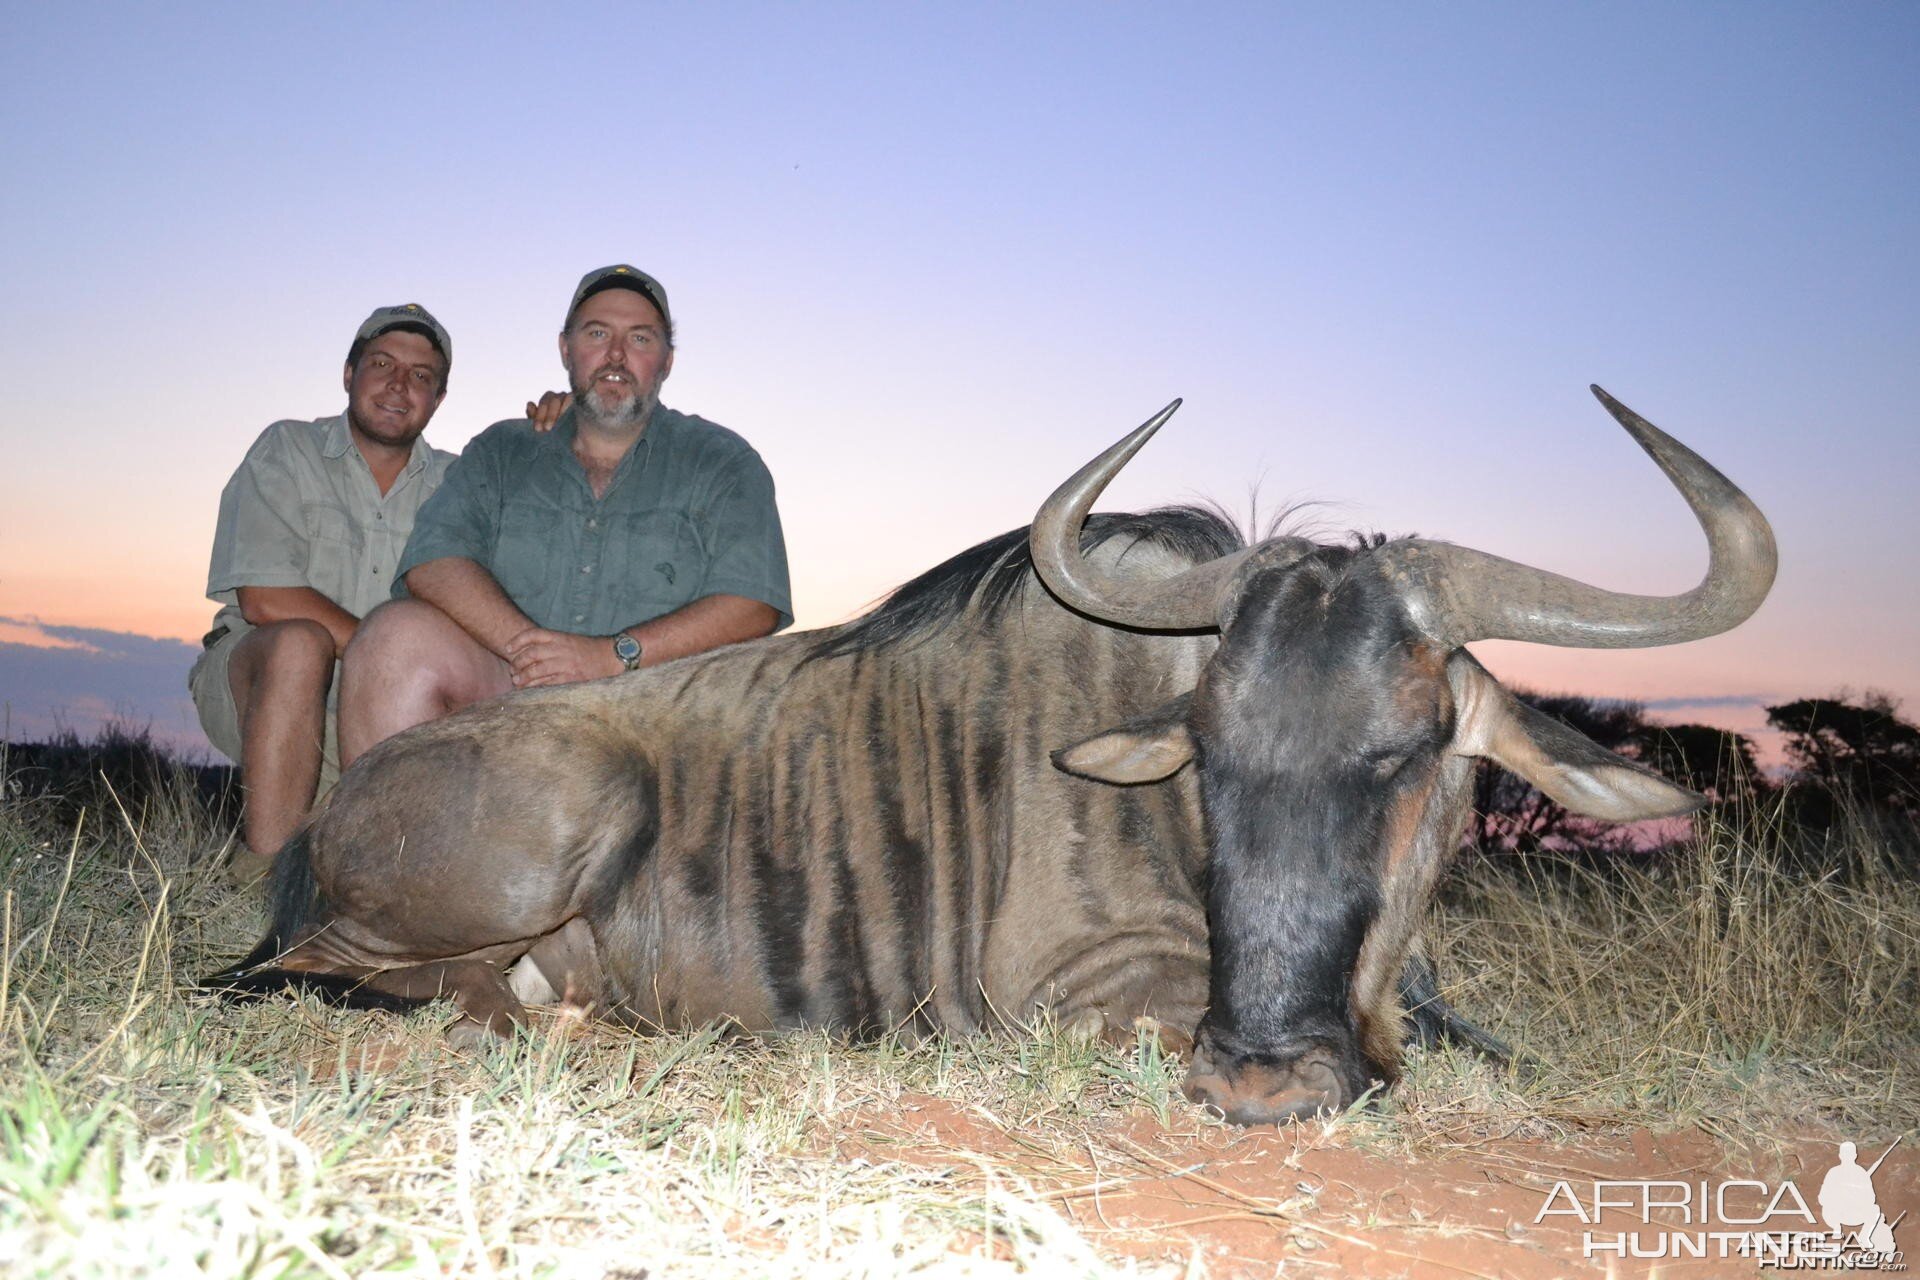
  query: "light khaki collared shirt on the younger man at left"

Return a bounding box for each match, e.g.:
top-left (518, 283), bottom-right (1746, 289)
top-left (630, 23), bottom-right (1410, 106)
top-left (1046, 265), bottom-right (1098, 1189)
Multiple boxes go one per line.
top-left (207, 415), bottom-right (453, 631)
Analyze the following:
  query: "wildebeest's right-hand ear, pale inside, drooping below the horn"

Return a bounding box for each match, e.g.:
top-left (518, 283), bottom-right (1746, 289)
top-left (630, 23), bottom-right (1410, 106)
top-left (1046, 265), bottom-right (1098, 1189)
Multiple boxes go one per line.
top-left (1448, 652), bottom-right (1707, 821)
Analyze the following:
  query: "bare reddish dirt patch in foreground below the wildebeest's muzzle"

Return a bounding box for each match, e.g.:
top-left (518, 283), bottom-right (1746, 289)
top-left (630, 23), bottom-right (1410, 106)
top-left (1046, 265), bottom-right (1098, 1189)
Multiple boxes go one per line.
top-left (829, 1096), bottom-right (1920, 1280)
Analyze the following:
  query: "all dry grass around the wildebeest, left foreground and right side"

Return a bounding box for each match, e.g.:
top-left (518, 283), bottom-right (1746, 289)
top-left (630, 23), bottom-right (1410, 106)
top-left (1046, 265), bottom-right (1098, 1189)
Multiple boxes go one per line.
top-left (0, 756), bottom-right (1920, 1280)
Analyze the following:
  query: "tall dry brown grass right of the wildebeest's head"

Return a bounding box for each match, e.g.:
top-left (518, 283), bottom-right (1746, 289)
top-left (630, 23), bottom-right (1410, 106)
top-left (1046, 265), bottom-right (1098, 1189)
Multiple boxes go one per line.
top-left (1394, 804), bottom-right (1920, 1144)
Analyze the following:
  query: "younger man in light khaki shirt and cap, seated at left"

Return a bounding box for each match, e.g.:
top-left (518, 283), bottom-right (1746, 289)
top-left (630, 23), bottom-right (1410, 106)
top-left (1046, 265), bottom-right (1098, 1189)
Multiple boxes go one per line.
top-left (188, 303), bottom-right (453, 883)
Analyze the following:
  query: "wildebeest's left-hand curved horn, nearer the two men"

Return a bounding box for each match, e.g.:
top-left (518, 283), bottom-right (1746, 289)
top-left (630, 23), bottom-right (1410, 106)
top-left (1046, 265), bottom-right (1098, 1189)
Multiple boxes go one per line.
top-left (1031, 401), bottom-right (1313, 631)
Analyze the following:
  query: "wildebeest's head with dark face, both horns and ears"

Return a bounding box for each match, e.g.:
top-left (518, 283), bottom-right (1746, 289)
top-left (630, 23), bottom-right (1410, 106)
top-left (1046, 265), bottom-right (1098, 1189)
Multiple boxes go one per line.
top-left (1033, 388), bottom-right (1776, 1125)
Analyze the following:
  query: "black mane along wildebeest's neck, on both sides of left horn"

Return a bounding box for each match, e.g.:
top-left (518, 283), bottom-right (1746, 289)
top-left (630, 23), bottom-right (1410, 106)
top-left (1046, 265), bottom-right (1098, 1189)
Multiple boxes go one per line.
top-left (808, 507), bottom-right (1242, 658)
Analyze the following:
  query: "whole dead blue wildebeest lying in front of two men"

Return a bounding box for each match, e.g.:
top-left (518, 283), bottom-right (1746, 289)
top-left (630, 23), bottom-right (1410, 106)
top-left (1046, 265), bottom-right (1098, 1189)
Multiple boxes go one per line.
top-left (209, 388), bottom-right (1774, 1123)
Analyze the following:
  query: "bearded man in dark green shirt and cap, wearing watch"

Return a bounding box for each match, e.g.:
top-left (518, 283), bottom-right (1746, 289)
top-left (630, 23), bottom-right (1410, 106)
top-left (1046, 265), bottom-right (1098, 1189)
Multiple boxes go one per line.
top-left (340, 265), bottom-right (793, 762)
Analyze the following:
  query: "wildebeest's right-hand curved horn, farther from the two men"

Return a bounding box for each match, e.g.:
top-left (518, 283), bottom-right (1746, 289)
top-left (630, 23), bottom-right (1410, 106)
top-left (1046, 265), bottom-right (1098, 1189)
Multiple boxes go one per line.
top-left (1380, 386), bottom-right (1780, 649)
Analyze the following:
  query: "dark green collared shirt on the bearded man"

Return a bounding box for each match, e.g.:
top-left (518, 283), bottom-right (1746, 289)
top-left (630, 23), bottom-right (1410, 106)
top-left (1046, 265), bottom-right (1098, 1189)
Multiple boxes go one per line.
top-left (399, 405), bottom-right (793, 635)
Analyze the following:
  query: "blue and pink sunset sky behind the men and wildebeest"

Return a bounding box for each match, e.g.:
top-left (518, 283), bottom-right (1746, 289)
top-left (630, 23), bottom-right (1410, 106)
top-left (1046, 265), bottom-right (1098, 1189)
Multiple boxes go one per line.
top-left (0, 0), bottom-right (1920, 756)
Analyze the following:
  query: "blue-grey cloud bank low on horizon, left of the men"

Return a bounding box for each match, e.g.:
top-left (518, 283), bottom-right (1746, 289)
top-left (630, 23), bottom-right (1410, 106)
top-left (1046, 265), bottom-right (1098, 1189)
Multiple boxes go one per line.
top-left (0, 618), bottom-right (217, 758)
